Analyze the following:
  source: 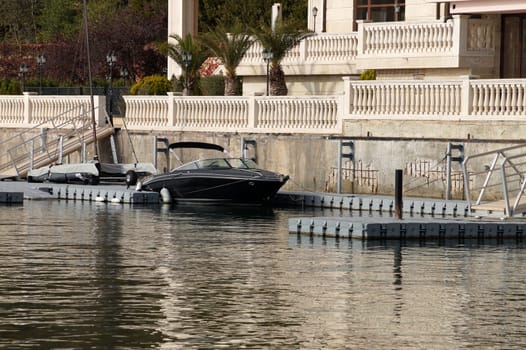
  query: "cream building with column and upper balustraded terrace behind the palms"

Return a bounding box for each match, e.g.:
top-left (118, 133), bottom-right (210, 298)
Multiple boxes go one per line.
top-left (168, 0), bottom-right (526, 95)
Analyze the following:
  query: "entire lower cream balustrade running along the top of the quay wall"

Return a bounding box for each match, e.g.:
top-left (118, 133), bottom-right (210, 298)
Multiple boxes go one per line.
top-left (0, 78), bottom-right (526, 135)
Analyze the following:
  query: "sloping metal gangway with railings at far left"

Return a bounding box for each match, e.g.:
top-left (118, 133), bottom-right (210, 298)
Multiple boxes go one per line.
top-left (0, 105), bottom-right (114, 180)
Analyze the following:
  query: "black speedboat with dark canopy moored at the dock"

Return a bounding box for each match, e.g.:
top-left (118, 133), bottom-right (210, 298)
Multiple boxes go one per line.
top-left (142, 142), bottom-right (289, 204)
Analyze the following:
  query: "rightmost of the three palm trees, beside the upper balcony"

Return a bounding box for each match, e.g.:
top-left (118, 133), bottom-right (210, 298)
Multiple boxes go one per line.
top-left (254, 22), bottom-right (314, 96)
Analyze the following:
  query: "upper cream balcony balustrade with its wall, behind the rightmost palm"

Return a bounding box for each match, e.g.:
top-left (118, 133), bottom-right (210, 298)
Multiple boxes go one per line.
top-left (239, 16), bottom-right (497, 75)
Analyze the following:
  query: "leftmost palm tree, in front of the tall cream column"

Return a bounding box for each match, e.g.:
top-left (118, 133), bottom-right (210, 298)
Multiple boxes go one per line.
top-left (167, 34), bottom-right (209, 95)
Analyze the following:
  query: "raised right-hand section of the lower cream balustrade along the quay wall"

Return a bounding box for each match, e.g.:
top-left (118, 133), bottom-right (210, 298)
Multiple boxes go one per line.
top-left (344, 79), bottom-right (526, 120)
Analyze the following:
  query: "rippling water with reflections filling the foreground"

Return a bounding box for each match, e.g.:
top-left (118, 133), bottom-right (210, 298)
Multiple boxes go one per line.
top-left (0, 202), bottom-right (526, 349)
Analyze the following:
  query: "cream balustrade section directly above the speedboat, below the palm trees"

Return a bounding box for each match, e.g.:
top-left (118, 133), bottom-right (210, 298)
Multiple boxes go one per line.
top-left (124, 94), bottom-right (341, 134)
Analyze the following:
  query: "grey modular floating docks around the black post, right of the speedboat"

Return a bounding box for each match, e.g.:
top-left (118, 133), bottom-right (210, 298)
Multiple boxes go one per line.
top-left (276, 191), bottom-right (526, 242)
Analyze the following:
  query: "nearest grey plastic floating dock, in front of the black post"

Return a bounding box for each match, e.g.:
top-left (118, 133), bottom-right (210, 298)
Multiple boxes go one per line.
top-left (289, 217), bottom-right (526, 241)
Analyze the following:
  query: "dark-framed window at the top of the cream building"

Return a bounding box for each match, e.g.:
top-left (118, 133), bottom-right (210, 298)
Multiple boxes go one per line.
top-left (355, 0), bottom-right (405, 22)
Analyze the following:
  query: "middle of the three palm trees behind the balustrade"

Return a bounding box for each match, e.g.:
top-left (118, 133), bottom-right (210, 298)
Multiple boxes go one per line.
top-left (203, 25), bottom-right (254, 96)
